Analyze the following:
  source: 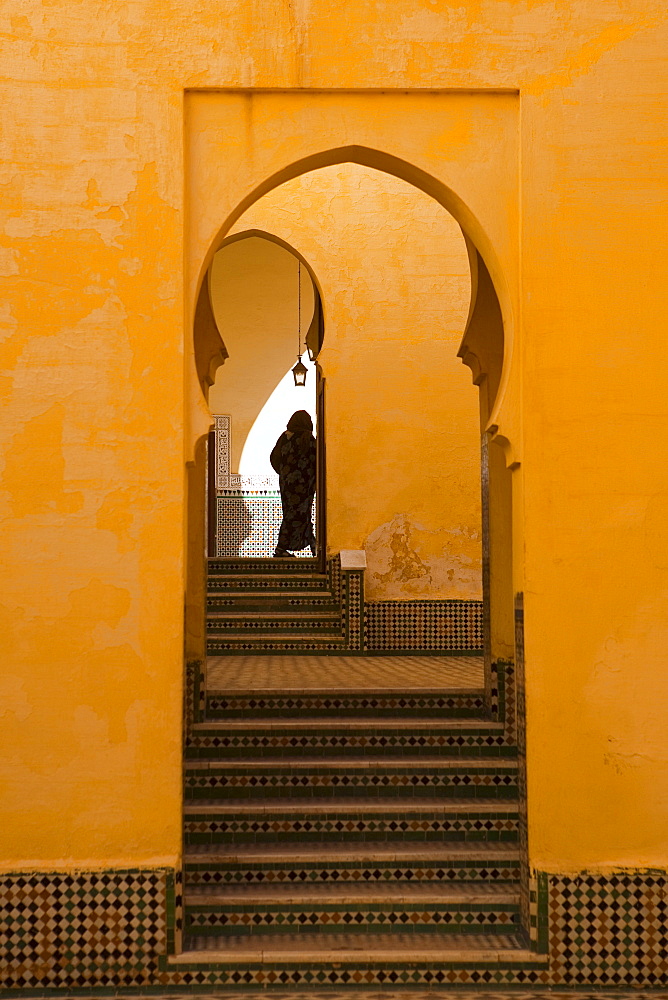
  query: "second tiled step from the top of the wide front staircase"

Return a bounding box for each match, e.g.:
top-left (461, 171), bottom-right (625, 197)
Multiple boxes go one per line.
top-left (185, 718), bottom-right (508, 760)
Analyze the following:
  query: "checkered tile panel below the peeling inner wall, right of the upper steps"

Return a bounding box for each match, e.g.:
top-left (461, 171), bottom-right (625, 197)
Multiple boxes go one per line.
top-left (364, 601), bottom-right (483, 652)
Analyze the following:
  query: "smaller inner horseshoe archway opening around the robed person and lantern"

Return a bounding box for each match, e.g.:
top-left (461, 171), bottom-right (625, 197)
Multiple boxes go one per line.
top-left (208, 236), bottom-right (322, 558)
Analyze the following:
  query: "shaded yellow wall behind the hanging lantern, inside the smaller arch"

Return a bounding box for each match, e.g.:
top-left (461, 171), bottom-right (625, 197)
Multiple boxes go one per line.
top-left (209, 236), bottom-right (313, 472)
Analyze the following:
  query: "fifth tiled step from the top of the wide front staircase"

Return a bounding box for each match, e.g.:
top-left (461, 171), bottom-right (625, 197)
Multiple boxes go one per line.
top-left (184, 839), bottom-right (520, 889)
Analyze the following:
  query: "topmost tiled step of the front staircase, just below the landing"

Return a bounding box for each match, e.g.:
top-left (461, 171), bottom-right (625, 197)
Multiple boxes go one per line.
top-left (206, 688), bottom-right (485, 723)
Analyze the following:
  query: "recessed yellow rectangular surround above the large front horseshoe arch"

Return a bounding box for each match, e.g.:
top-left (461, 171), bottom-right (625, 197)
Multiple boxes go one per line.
top-left (185, 91), bottom-right (520, 464)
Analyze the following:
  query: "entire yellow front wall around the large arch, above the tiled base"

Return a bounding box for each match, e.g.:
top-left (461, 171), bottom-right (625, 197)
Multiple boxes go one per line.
top-left (0, 0), bottom-right (668, 871)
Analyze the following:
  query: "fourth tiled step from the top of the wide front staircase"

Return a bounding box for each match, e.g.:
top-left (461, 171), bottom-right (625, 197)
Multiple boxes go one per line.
top-left (184, 798), bottom-right (519, 844)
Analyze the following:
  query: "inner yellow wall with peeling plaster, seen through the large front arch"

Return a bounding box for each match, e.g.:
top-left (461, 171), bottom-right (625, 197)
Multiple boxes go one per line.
top-left (230, 163), bottom-right (481, 600)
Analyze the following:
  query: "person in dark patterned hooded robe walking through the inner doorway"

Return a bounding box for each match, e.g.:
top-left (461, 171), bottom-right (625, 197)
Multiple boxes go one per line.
top-left (269, 410), bottom-right (316, 556)
